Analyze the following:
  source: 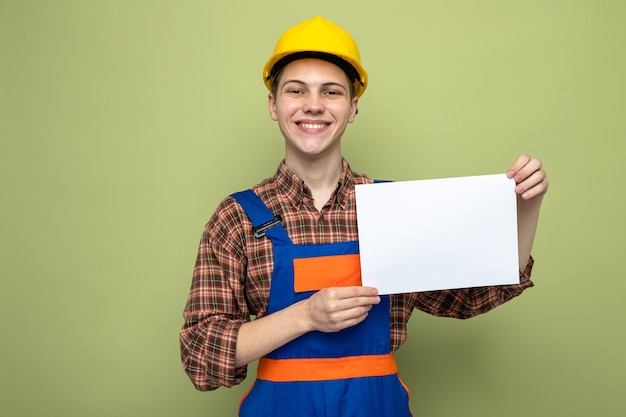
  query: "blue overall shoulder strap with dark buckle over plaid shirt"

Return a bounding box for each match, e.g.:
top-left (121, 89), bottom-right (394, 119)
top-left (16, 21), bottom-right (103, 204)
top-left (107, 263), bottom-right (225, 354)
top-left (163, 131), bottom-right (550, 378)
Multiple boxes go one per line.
top-left (231, 190), bottom-right (291, 245)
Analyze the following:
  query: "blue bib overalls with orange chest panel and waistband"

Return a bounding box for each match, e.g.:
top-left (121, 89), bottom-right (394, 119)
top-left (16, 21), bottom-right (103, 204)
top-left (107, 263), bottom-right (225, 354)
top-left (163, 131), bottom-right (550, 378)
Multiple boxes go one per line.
top-left (233, 190), bottom-right (411, 417)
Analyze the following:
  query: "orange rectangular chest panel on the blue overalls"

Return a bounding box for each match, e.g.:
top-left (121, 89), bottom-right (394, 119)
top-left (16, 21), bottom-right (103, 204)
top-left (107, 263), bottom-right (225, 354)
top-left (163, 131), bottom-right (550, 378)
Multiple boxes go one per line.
top-left (293, 254), bottom-right (361, 292)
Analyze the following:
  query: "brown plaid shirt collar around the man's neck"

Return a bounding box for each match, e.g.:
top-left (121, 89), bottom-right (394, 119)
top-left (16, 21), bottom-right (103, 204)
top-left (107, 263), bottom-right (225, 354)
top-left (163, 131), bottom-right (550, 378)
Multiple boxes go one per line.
top-left (274, 159), bottom-right (354, 209)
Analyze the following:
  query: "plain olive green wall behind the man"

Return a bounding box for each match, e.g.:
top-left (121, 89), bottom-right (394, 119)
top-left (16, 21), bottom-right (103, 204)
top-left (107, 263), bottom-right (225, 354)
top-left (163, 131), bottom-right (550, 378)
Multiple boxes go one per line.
top-left (0, 0), bottom-right (626, 417)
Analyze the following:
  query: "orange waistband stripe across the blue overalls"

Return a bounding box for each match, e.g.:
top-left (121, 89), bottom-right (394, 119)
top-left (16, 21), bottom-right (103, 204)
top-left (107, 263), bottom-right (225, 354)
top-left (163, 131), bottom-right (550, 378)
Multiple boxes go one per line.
top-left (257, 353), bottom-right (398, 382)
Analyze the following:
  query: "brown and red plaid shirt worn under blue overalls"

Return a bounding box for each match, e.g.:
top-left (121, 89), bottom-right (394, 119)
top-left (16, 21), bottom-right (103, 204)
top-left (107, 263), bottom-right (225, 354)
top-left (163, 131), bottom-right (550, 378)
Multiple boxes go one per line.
top-left (180, 160), bottom-right (533, 391)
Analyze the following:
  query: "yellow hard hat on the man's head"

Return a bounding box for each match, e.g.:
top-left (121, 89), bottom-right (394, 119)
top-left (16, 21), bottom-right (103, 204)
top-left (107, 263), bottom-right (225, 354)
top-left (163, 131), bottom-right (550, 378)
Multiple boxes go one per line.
top-left (263, 16), bottom-right (367, 97)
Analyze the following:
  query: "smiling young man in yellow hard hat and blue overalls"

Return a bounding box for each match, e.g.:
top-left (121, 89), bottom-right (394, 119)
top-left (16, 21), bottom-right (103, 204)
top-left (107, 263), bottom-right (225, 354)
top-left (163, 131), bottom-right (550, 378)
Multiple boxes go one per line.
top-left (181, 17), bottom-right (548, 417)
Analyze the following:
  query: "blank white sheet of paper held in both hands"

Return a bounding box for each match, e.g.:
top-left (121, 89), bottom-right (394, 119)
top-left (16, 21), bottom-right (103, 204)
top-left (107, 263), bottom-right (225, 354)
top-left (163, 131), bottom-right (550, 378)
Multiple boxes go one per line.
top-left (356, 174), bottom-right (519, 294)
